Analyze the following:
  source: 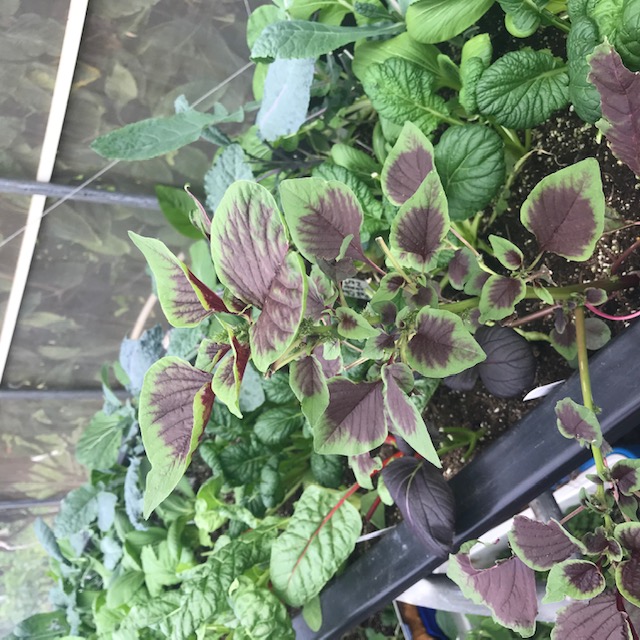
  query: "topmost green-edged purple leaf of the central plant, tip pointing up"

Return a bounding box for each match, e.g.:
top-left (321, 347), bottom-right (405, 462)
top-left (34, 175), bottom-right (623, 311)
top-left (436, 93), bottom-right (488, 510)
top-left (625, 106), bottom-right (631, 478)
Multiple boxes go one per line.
top-left (382, 122), bottom-right (433, 206)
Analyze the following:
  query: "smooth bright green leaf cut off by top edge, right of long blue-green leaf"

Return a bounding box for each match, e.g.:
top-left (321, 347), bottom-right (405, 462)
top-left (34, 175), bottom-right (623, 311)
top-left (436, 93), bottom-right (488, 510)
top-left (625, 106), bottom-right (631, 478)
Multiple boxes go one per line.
top-left (406, 0), bottom-right (493, 43)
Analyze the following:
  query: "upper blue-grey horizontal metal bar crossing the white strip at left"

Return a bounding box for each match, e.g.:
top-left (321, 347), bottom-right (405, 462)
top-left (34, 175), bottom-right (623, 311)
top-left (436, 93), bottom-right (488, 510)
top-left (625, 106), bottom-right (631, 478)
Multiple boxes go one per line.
top-left (0, 178), bottom-right (160, 211)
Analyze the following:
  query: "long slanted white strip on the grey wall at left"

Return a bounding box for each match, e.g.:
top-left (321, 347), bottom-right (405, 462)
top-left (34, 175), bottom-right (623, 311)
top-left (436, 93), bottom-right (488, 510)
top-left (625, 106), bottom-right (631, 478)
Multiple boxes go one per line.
top-left (0, 0), bottom-right (89, 383)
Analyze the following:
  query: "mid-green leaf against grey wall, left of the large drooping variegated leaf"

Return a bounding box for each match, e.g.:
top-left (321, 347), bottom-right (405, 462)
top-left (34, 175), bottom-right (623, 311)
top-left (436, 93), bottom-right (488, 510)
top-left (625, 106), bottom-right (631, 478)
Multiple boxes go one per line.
top-left (76, 411), bottom-right (128, 469)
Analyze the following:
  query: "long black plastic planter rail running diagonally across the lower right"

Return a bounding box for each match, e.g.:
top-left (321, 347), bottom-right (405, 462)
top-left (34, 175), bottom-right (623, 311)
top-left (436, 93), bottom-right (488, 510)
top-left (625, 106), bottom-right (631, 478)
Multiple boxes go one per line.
top-left (293, 322), bottom-right (640, 640)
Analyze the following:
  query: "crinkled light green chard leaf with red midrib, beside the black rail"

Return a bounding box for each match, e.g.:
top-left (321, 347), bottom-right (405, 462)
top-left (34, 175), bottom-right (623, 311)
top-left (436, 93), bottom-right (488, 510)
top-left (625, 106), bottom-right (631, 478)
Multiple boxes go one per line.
top-left (270, 486), bottom-right (362, 607)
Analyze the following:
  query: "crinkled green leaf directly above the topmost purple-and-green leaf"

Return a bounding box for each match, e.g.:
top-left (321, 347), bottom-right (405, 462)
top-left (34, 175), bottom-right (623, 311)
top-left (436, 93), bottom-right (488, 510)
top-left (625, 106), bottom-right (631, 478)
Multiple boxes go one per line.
top-left (362, 58), bottom-right (452, 134)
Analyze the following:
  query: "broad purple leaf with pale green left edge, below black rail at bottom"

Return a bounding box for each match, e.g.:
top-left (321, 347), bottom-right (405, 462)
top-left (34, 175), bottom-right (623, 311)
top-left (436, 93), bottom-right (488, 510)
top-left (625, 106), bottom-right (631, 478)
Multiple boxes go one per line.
top-left (447, 553), bottom-right (538, 637)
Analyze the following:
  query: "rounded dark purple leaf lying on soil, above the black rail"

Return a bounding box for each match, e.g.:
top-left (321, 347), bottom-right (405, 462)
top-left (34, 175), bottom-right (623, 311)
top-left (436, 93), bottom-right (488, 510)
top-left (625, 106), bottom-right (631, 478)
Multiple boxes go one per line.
top-left (475, 326), bottom-right (536, 398)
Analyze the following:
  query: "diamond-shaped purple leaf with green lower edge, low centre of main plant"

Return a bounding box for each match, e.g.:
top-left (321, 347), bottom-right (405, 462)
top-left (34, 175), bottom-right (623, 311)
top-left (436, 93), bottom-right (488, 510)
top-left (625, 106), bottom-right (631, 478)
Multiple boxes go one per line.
top-left (313, 378), bottom-right (387, 455)
